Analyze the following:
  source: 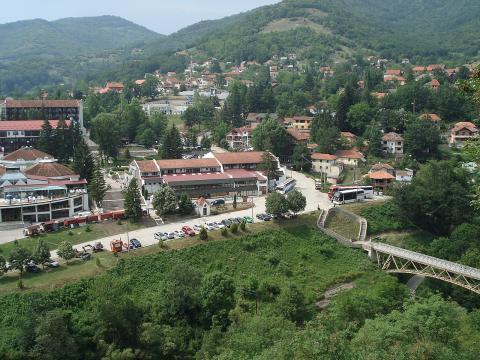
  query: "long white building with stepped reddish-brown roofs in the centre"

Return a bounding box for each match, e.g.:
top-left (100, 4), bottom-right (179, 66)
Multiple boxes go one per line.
top-left (126, 152), bottom-right (280, 198)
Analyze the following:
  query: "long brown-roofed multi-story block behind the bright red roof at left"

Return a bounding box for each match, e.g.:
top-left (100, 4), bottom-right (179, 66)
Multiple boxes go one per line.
top-left (0, 99), bottom-right (84, 129)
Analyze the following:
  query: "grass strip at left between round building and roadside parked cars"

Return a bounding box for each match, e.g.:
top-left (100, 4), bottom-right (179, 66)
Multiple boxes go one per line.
top-left (0, 221), bottom-right (155, 258)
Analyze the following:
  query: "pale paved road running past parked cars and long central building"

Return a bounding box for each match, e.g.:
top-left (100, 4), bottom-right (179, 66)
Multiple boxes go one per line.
top-left (52, 172), bottom-right (332, 258)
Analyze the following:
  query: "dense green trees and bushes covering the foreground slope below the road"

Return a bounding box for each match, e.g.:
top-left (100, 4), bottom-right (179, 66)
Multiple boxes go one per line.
top-left (0, 224), bottom-right (480, 360)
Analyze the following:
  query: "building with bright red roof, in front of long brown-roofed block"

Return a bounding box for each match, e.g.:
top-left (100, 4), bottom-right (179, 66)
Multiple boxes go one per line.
top-left (0, 120), bottom-right (71, 153)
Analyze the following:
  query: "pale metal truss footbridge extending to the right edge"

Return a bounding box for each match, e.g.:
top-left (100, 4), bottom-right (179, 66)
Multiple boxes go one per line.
top-left (362, 242), bottom-right (480, 295)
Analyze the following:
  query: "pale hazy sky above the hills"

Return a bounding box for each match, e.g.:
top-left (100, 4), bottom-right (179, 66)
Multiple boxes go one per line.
top-left (0, 0), bottom-right (279, 34)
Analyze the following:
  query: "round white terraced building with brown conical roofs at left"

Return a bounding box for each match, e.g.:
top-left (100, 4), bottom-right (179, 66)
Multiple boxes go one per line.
top-left (0, 148), bottom-right (89, 223)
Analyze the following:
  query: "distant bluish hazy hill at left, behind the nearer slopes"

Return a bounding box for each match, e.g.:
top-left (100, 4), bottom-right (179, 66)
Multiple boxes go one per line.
top-left (0, 16), bottom-right (160, 60)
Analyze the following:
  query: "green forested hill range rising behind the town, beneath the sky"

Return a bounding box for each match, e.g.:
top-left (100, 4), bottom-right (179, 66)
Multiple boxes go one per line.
top-left (0, 0), bottom-right (480, 95)
